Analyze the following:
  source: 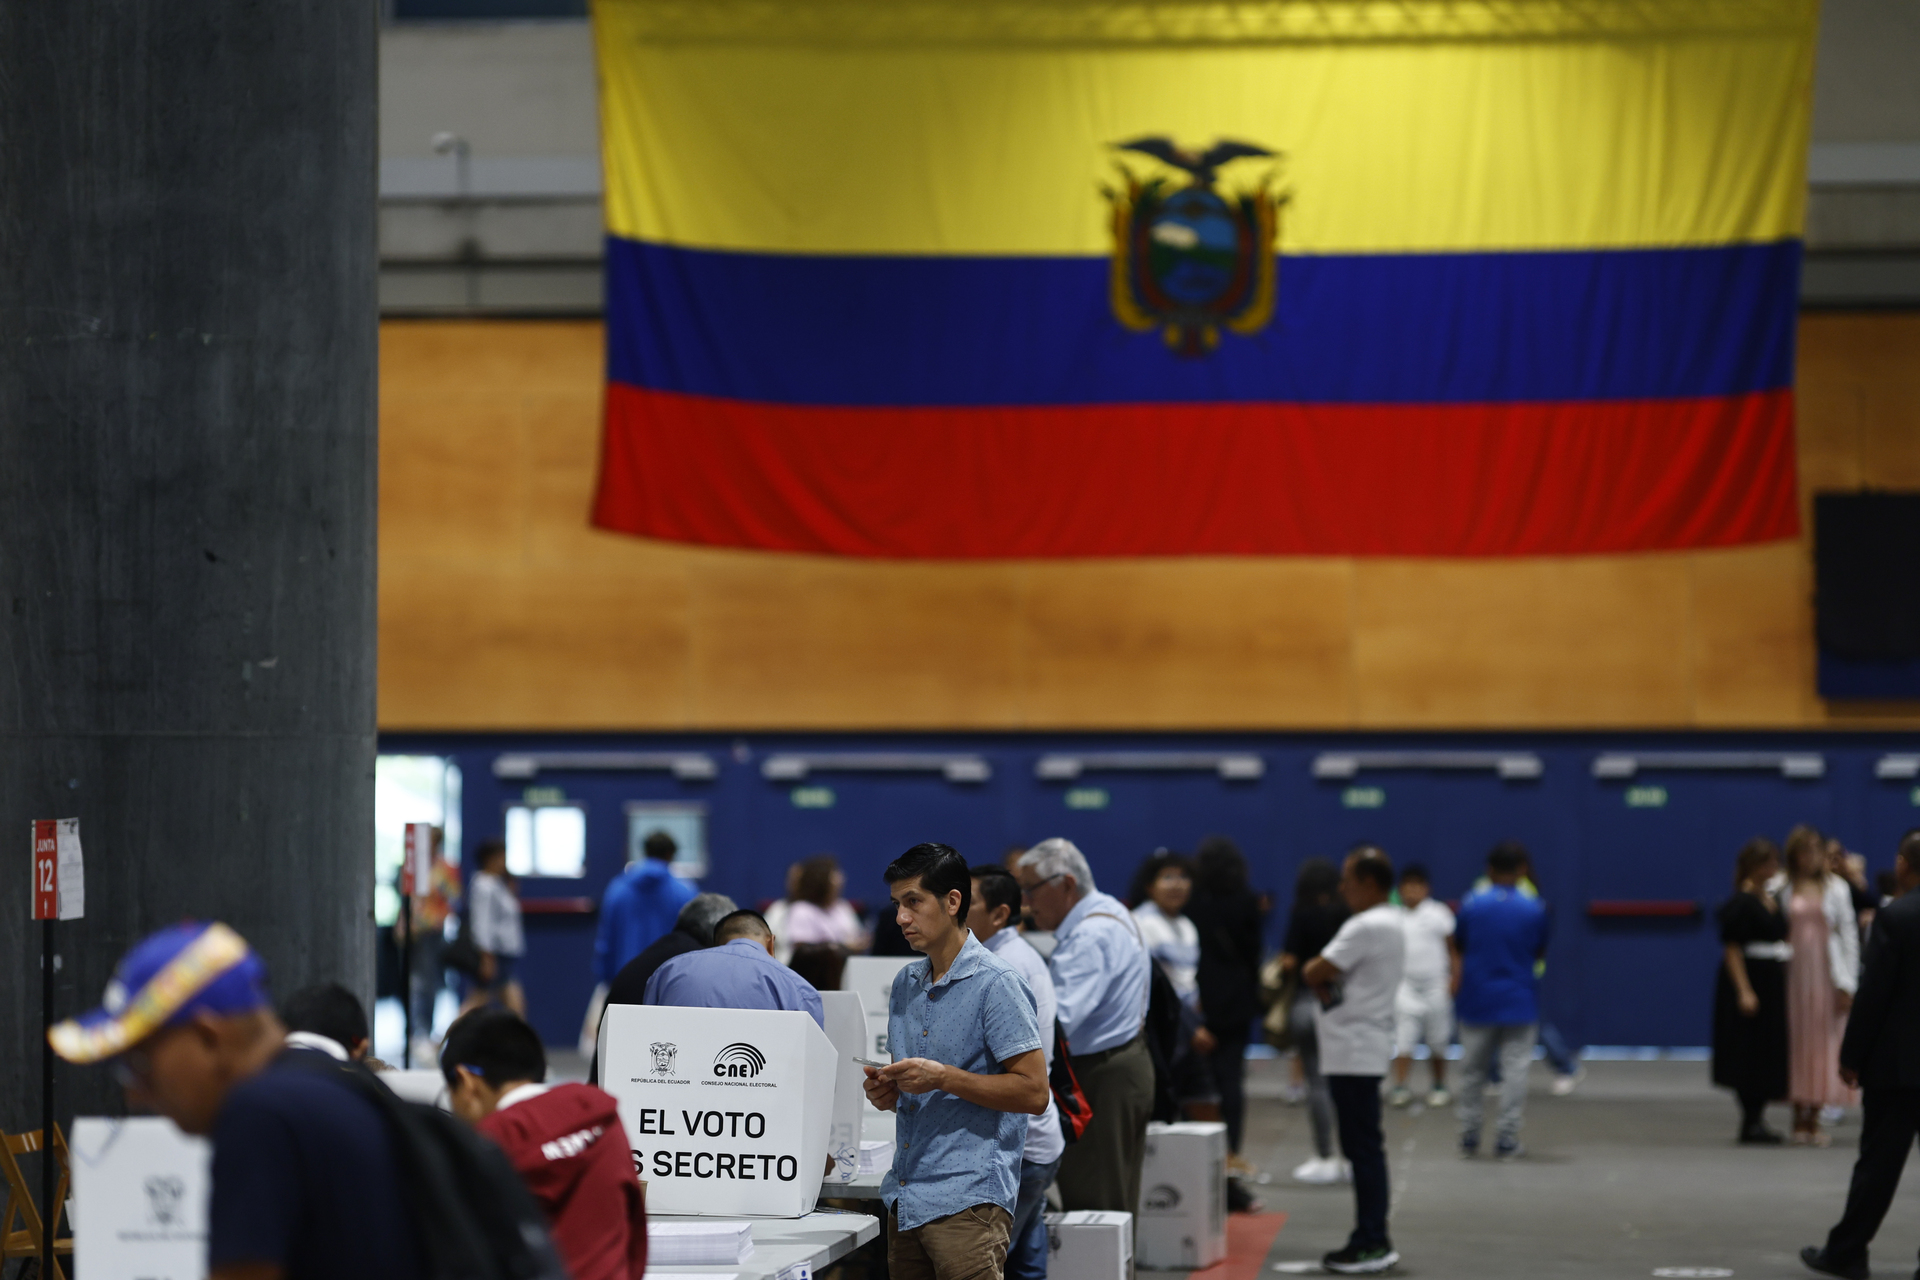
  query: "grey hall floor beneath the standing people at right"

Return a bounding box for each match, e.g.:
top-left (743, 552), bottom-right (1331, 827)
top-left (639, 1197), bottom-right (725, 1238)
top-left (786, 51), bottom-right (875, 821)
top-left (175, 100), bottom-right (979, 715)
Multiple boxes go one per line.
top-left (1246, 1061), bottom-right (1920, 1278)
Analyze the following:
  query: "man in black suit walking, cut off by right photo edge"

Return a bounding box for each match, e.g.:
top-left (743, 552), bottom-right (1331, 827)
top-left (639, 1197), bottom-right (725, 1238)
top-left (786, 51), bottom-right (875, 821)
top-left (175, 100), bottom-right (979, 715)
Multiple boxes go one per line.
top-left (1801, 827), bottom-right (1920, 1280)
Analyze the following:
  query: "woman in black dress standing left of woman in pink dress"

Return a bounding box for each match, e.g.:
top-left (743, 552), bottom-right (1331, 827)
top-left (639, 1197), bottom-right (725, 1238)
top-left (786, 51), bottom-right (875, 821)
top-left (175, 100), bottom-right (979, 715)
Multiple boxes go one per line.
top-left (1713, 839), bottom-right (1789, 1146)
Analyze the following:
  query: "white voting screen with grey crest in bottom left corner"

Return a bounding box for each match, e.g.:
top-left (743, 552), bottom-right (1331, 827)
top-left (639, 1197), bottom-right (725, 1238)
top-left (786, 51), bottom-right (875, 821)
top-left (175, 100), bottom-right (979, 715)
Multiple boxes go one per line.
top-left (67, 1115), bottom-right (213, 1280)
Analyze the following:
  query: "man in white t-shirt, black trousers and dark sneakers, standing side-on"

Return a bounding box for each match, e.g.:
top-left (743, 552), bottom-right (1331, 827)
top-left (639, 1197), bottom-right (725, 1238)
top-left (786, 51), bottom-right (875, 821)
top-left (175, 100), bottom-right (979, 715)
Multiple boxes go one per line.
top-left (1300, 844), bottom-right (1407, 1276)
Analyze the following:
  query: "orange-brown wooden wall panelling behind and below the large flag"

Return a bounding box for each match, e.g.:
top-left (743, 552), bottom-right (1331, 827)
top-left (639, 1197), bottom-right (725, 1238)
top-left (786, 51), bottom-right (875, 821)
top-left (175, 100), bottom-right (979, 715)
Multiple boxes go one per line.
top-left (380, 315), bottom-right (1920, 729)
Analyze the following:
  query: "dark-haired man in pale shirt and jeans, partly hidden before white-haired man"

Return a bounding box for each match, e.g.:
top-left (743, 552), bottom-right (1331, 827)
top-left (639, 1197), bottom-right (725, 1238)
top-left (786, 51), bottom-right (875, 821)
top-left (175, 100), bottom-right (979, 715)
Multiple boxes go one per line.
top-left (966, 862), bottom-right (1068, 1280)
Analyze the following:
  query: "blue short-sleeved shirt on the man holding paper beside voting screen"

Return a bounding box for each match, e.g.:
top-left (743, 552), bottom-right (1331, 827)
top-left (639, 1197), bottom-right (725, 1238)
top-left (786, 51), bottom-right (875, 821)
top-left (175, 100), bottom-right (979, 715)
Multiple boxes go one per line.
top-left (879, 931), bottom-right (1041, 1230)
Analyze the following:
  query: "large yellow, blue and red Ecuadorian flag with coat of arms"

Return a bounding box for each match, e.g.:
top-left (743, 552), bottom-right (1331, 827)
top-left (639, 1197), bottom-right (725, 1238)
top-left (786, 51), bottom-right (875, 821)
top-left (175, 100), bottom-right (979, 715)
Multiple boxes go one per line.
top-left (593, 0), bottom-right (1816, 557)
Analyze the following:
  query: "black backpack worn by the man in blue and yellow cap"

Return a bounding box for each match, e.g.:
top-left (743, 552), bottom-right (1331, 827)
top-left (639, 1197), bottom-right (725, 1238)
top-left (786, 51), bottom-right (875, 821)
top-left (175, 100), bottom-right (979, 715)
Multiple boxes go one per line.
top-left (280, 1054), bottom-right (568, 1280)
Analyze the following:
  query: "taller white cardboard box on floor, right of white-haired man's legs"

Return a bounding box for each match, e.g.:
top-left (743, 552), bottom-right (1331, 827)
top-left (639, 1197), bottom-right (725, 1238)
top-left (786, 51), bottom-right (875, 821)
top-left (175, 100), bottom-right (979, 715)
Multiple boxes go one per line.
top-left (1135, 1121), bottom-right (1227, 1270)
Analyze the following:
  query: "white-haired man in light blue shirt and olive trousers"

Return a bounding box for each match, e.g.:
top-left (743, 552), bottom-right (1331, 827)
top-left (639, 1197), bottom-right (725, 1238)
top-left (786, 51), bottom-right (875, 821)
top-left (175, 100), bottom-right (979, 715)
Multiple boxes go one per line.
top-left (1014, 837), bottom-right (1154, 1213)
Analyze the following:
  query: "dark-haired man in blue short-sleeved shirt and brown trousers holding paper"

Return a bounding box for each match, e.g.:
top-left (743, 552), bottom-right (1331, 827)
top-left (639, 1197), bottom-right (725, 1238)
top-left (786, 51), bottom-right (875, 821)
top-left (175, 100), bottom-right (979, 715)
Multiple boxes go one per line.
top-left (866, 844), bottom-right (1050, 1280)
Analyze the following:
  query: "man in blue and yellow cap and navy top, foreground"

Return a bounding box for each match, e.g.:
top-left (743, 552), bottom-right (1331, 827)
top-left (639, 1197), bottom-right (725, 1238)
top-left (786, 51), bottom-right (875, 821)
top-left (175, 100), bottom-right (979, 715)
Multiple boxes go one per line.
top-left (46, 923), bottom-right (424, 1280)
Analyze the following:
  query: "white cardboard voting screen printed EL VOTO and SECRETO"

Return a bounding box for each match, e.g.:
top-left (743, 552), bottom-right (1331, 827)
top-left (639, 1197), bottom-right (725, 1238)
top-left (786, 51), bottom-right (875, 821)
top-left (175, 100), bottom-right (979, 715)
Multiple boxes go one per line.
top-left (599, 1004), bottom-right (837, 1219)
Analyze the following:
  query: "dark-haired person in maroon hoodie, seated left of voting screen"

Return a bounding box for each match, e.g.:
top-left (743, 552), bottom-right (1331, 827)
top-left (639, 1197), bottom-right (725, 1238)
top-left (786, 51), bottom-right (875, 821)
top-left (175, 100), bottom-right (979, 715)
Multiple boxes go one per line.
top-left (440, 1007), bottom-right (647, 1280)
